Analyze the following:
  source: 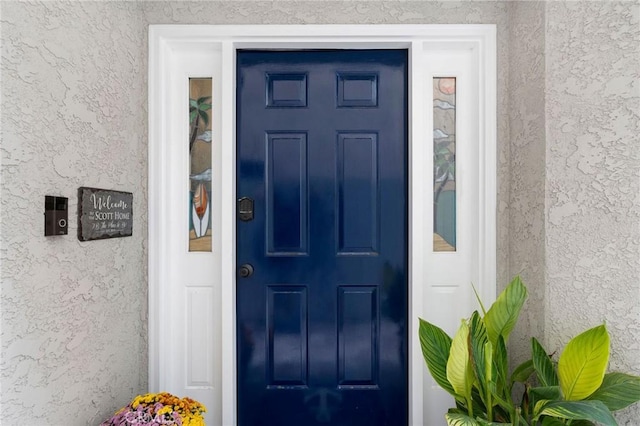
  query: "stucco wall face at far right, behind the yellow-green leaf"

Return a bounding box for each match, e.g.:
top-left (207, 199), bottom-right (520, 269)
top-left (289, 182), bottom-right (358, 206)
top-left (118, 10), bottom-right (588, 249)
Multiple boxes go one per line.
top-left (545, 2), bottom-right (640, 425)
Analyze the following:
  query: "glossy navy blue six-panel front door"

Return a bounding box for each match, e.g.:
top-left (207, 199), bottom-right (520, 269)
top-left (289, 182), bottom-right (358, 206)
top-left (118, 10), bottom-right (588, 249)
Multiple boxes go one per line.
top-left (236, 50), bottom-right (408, 426)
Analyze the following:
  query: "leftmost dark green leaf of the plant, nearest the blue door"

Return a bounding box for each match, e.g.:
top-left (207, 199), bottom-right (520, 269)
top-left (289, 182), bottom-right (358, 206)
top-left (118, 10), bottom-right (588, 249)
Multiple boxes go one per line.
top-left (419, 318), bottom-right (455, 396)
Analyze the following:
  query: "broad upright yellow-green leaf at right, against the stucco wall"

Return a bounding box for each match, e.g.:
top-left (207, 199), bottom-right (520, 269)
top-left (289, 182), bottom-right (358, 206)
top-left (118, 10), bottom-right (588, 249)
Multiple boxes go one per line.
top-left (558, 325), bottom-right (609, 401)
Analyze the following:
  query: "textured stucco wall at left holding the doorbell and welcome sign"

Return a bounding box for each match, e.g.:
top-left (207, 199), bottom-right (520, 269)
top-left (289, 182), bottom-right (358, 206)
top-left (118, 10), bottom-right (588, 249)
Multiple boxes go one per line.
top-left (0, 2), bottom-right (147, 426)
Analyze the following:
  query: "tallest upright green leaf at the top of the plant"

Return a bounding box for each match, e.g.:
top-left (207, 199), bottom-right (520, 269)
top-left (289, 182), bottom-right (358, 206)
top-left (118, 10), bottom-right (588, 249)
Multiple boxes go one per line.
top-left (484, 276), bottom-right (527, 346)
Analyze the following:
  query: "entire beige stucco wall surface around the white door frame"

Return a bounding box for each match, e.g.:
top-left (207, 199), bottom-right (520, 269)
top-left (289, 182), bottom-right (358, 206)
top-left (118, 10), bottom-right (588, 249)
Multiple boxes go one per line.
top-left (0, 1), bottom-right (640, 426)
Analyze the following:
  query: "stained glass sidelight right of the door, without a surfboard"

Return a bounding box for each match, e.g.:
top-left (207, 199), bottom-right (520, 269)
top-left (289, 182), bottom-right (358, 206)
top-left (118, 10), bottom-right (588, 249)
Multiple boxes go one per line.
top-left (433, 77), bottom-right (456, 251)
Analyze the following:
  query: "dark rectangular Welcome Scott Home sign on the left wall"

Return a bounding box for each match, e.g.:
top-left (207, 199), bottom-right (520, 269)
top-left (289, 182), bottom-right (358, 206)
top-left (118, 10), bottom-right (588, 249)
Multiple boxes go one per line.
top-left (78, 186), bottom-right (133, 241)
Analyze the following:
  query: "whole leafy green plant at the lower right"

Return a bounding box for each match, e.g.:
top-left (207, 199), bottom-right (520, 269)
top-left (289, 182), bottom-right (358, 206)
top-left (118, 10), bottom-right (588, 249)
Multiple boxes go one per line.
top-left (419, 277), bottom-right (640, 426)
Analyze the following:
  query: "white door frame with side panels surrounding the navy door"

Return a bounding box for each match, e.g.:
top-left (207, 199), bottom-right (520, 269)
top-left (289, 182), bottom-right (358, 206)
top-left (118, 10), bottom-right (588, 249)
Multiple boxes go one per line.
top-left (148, 25), bottom-right (496, 426)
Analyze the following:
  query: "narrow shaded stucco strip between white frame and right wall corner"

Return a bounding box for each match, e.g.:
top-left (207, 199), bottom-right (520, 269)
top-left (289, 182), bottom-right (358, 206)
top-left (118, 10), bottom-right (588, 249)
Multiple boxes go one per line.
top-left (499, 1), bottom-right (545, 365)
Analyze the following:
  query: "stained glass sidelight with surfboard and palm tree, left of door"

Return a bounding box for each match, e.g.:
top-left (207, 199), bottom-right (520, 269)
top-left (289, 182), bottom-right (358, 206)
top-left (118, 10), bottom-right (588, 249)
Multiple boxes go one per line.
top-left (189, 78), bottom-right (212, 251)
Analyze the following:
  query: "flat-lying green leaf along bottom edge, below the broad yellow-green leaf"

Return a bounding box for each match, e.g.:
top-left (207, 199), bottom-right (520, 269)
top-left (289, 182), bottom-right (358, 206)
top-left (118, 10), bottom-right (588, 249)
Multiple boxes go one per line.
top-left (535, 401), bottom-right (618, 426)
